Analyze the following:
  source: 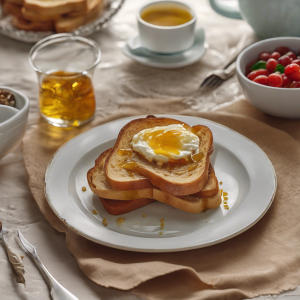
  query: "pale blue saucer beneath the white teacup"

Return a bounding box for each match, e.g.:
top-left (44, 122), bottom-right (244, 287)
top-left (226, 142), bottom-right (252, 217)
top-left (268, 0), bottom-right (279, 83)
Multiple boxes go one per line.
top-left (123, 28), bottom-right (208, 69)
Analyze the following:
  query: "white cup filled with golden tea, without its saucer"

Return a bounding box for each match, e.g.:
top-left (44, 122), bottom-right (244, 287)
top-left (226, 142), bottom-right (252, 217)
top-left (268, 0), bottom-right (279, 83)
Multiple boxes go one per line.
top-left (137, 0), bottom-right (197, 54)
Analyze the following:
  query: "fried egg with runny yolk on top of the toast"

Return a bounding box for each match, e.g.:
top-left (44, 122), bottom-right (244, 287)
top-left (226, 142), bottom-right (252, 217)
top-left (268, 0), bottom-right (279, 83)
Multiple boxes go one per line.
top-left (131, 124), bottom-right (199, 165)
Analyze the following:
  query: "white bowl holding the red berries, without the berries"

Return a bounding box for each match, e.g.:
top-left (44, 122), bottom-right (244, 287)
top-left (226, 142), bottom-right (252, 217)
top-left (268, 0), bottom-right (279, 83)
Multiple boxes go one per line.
top-left (236, 37), bottom-right (300, 119)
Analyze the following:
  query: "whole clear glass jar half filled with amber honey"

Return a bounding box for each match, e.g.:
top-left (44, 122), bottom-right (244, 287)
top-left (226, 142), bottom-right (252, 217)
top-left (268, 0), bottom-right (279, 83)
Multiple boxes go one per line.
top-left (29, 34), bottom-right (101, 127)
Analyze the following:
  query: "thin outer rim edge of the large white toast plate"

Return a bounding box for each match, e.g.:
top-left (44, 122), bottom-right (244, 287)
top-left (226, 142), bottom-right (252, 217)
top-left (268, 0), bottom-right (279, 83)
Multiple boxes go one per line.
top-left (44, 114), bottom-right (277, 253)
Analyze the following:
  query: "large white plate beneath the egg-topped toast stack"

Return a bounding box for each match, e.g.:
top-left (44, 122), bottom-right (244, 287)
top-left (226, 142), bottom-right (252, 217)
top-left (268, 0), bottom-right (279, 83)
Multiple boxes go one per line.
top-left (45, 116), bottom-right (277, 252)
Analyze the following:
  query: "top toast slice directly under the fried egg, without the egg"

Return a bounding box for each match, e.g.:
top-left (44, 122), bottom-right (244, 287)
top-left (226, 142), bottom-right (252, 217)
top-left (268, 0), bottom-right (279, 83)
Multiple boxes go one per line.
top-left (105, 116), bottom-right (213, 196)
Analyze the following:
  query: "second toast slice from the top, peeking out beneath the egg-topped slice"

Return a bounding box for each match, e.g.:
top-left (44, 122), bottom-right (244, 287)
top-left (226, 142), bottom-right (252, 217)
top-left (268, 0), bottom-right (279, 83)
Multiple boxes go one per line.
top-left (87, 148), bottom-right (219, 201)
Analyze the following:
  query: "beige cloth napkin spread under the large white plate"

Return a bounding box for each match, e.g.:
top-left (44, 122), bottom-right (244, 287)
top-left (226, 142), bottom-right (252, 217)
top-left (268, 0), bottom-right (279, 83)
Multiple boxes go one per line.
top-left (23, 99), bottom-right (300, 299)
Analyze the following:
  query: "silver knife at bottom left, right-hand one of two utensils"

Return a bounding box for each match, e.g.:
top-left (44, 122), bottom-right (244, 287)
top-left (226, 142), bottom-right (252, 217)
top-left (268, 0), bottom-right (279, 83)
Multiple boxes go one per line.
top-left (18, 229), bottom-right (79, 300)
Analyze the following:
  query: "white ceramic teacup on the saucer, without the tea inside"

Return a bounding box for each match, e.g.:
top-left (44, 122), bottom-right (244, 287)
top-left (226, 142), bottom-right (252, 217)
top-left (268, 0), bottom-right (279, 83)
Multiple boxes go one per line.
top-left (137, 0), bottom-right (197, 54)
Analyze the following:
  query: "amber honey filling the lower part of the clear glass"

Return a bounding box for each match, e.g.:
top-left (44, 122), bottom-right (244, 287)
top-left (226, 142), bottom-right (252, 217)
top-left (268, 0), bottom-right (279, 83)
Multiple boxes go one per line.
top-left (39, 71), bottom-right (96, 127)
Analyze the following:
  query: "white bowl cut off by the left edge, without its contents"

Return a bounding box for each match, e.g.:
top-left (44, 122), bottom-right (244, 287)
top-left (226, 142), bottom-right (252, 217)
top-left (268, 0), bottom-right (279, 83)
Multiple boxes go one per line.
top-left (0, 86), bottom-right (29, 158)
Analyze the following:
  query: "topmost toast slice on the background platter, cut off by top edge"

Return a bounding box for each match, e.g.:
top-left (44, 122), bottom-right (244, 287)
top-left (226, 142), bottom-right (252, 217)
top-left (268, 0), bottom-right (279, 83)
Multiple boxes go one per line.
top-left (24, 0), bottom-right (92, 16)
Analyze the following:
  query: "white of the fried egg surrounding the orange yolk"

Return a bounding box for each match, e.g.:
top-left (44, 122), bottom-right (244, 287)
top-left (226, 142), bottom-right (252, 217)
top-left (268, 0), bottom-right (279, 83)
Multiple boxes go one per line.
top-left (131, 124), bottom-right (199, 165)
